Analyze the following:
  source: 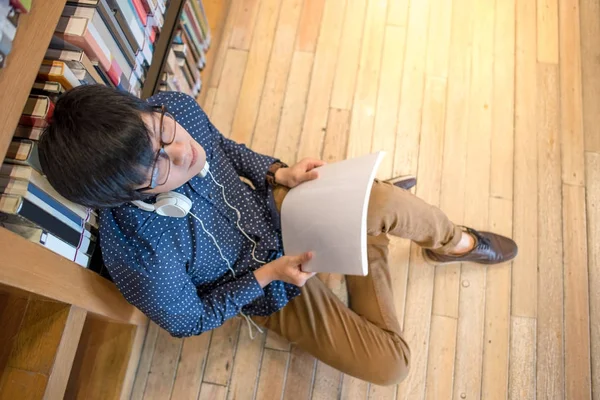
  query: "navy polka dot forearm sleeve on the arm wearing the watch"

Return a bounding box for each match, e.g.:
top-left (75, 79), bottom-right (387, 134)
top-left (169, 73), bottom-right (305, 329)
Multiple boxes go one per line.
top-left (217, 132), bottom-right (279, 191)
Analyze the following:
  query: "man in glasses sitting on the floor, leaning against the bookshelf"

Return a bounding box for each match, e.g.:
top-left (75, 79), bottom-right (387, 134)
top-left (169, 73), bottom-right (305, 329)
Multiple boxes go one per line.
top-left (40, 86), bottom-right (517, 385)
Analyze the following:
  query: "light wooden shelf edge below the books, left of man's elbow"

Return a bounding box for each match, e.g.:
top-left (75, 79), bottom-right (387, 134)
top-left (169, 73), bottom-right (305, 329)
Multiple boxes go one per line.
top-left (0, 228), bottom-right (147, 325)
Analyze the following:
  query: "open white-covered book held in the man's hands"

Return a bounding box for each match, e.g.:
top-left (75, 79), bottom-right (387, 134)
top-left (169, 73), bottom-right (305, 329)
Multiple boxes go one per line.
top-left (281, 152), bottom-right (385, 276)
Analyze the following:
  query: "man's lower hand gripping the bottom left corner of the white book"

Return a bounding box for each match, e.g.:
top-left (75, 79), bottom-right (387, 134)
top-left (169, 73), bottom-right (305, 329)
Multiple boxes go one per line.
top-left (254, 252), bottom-right (316, 288)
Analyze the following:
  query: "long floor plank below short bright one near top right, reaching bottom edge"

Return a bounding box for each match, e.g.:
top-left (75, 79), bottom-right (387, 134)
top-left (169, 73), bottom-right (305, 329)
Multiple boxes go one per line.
top-left (537, 64), bottom-right (564, 398)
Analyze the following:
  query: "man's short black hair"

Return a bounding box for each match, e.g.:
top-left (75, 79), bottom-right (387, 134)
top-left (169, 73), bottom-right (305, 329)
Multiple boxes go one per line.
top-left (39, 85), bottom-right (155, 208)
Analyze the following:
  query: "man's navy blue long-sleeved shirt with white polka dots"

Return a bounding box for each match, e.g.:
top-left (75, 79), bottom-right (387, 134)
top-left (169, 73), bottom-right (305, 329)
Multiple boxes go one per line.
top-left (100, 92), bottom-right (300, 337)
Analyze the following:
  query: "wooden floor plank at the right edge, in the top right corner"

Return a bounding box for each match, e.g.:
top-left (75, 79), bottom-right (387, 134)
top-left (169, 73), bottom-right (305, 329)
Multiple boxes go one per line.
top-left (579, 0), bottom-right (600, 153)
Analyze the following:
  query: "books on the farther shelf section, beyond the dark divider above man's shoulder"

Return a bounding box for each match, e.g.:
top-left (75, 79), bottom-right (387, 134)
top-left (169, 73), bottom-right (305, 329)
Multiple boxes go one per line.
top-left (159, 0), bottom-right (211, 96)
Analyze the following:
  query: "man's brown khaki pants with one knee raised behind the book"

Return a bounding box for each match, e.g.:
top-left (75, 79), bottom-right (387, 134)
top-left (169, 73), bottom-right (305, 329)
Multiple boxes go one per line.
top-left (252, 181), bottom-right (461, 385)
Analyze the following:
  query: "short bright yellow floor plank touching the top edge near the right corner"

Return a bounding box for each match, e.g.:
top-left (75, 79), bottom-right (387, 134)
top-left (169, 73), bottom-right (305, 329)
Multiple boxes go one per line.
top-left (537, 0), bottom-right (558, 64)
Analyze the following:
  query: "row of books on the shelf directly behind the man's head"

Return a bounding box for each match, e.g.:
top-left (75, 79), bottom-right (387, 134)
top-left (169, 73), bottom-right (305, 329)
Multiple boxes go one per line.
top-left (0, 0), bottom-right (178, 267)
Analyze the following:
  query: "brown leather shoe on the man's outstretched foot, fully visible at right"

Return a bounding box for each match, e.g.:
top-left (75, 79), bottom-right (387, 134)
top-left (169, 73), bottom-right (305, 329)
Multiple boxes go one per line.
top-left (423, 228), bottom-right (518, 265)
